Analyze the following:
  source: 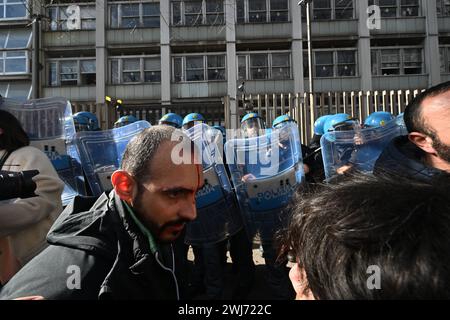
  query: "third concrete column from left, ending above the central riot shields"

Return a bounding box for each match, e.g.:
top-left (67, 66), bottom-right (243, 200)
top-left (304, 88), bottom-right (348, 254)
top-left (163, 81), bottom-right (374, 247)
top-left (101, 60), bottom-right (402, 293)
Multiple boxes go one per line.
top-left (225, 0), bottom-right (239, 129)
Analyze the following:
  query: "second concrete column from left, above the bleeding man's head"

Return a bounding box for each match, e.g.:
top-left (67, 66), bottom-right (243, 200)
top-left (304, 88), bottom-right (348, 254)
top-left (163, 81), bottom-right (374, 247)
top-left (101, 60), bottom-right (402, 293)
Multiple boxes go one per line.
top-left (159, 0), bottom-right (172, 106)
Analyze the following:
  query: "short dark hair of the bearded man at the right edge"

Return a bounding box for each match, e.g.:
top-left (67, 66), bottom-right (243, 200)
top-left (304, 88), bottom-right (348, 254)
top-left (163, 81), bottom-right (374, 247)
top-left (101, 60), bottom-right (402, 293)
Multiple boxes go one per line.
top-left (403, 81), bottom-right (450, 134)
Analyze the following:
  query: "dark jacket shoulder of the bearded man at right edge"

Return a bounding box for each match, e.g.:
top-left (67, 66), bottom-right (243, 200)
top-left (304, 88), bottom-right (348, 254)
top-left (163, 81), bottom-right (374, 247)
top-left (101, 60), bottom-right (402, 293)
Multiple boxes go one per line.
top-left (373, 136), bottom-right (448, 181)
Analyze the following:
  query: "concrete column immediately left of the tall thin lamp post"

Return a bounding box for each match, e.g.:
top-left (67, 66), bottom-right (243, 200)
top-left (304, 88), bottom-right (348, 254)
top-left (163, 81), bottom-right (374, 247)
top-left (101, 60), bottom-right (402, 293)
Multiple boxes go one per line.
top-left (290, 0), bottom-right (305, 94)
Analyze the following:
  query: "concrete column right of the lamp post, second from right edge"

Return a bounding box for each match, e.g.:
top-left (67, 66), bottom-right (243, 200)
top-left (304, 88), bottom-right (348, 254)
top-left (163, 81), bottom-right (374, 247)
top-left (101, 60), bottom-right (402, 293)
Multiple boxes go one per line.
top-left (354, 0), bottom-right (373, 91)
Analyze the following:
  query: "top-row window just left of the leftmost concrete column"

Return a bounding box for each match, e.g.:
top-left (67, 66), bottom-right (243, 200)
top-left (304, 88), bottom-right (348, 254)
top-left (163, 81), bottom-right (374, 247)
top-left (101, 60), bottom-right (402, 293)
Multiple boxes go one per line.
top-left (47, 5), bottom-right (95, 31)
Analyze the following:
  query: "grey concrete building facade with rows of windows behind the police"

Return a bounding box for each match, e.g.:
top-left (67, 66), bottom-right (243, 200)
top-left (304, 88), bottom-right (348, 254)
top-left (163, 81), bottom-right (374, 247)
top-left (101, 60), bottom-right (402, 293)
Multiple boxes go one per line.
top-left (0, 0), bottom-right (450, 127)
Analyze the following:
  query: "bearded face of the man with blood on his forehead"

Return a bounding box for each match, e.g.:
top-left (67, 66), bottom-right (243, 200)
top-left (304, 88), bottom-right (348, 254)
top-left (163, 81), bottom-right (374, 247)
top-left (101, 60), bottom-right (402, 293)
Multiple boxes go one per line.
top-left (133, 141), bottom-right (203, 242)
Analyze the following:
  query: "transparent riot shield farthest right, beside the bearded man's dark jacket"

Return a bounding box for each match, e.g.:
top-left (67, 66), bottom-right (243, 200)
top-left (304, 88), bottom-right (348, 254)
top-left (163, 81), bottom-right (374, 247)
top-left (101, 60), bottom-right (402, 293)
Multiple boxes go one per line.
top-left (320, 119), bottom-right (401, 180)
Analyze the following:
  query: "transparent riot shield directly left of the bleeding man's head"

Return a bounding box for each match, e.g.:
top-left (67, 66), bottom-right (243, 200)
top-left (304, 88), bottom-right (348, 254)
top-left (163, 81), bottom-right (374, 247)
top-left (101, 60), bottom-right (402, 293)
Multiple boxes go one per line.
top-left (69, 121), bottom-right (151, 196)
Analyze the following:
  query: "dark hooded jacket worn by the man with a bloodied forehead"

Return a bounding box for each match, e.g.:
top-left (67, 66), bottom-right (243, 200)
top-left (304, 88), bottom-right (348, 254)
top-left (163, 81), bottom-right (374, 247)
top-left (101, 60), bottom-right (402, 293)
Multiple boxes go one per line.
top-left (0, 191), bottom-right (179, 300)
